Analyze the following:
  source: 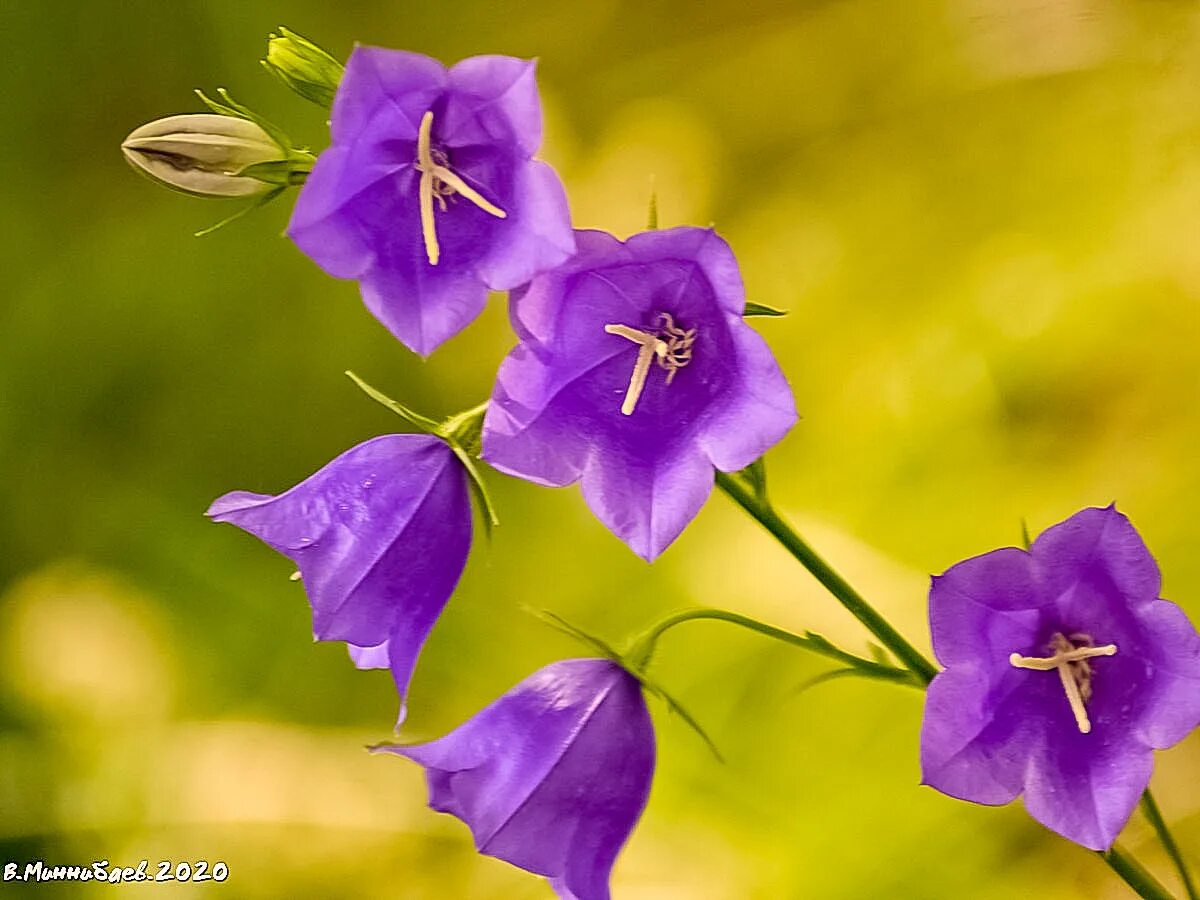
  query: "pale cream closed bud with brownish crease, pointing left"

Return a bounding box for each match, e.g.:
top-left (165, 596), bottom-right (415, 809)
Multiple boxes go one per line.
top-left (121, 113), bottom-right (289, 197)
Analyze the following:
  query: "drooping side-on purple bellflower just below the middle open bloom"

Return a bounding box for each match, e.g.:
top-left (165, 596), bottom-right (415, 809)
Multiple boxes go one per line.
top-left (208, 434), bottom-right (472, 720)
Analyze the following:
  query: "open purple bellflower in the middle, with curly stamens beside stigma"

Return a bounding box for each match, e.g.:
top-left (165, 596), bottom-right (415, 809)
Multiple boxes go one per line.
top-left (484, 228), bottom-right (796, 560)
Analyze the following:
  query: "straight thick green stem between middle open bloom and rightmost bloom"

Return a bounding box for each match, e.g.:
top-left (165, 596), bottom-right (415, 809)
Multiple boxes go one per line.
top-left (716, 472), bottom-right (937, 684)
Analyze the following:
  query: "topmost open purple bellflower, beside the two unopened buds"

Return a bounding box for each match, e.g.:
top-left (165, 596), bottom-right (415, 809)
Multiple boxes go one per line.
top-left (288, 47), bottom-right (575, 355)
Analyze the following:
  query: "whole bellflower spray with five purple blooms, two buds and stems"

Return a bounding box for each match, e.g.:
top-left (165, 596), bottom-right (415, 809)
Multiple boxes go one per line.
top-left (124, 29), bottom-right (1200, 900)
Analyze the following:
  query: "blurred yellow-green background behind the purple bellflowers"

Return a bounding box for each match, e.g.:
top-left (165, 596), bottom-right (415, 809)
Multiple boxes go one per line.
top-left (0, 0), bottom-right (1200, 900)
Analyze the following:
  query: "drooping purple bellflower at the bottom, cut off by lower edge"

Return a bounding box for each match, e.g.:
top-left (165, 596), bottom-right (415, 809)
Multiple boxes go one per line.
top-left (376, 659), bottom-right (654, 900)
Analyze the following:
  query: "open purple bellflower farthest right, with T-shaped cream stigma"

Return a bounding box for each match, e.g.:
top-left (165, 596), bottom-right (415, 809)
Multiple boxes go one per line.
top-left (920, 506), bottom-right (1200, 850)
